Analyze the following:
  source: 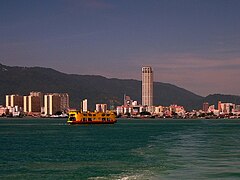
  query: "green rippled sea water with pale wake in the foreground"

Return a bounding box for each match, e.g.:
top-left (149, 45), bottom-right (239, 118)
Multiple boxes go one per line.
top-left (0, 119), bottom-right (240, 180)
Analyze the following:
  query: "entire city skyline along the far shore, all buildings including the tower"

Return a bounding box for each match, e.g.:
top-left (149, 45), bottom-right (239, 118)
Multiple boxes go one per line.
top-left (0, 66), bottom-right (240, 118)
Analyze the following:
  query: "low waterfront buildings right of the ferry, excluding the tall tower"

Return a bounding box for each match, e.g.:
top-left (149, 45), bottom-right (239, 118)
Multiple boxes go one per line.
top-left (116, 95), bottom-right (240, 118)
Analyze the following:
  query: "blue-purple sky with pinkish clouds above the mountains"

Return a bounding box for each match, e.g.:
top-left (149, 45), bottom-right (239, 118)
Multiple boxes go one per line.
top-left (0, 0), bottom-right (240, 96)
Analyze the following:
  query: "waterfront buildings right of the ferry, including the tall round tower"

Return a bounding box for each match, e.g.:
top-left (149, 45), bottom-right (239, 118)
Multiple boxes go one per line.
top-left (116, 66), bottom-right (240, 118)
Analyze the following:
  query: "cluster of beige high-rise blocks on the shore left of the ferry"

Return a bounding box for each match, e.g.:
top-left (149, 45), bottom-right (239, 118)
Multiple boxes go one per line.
top-left (0, 92), bottom-right (69, 116)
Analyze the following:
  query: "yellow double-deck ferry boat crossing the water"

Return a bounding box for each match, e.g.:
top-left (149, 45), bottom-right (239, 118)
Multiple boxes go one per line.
top-left (67, 111), bottom-right (117, 124)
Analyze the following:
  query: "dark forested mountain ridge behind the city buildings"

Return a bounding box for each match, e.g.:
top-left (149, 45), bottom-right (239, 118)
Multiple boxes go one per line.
top-left (0, 64), bottom-right (240, 110)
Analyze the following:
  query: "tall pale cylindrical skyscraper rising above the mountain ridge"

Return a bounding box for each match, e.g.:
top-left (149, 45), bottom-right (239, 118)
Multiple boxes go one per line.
top-left (142, 66), bottom-right (153, 107)
